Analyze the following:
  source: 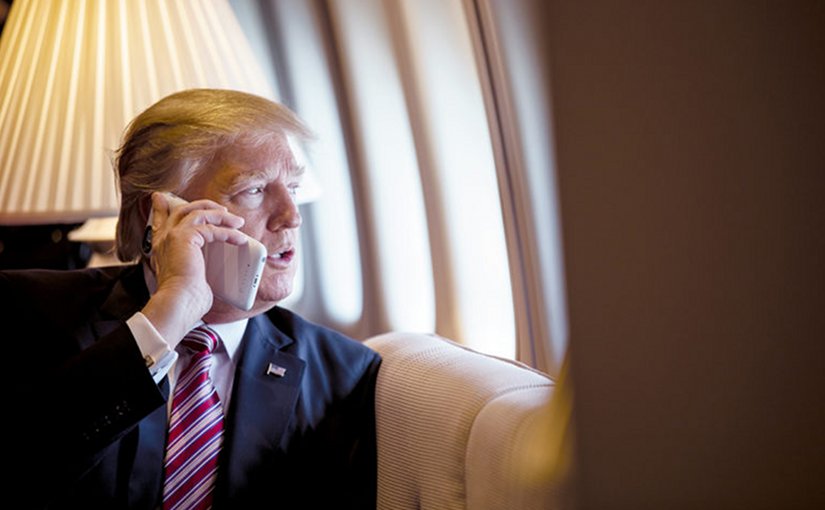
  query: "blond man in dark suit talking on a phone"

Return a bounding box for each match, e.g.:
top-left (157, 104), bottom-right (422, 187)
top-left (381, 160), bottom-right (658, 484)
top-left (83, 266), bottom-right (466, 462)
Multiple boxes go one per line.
top-left (0, 90), bottom-right (380, 509)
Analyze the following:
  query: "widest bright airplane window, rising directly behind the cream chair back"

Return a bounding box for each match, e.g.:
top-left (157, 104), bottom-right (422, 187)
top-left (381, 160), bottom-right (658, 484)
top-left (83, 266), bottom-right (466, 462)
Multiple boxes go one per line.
top-left (395, 0), bottom-right (516, 358)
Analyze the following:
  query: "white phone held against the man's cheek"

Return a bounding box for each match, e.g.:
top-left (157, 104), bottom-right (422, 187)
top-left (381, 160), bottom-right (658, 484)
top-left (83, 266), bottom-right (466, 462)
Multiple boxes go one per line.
top-left (145, 193), bottom-right (266, 310)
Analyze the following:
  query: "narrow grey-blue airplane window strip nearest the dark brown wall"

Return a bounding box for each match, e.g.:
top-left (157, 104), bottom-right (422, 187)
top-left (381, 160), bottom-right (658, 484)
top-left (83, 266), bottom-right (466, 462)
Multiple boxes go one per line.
top-left (476, 0), bottom-right (567, 374)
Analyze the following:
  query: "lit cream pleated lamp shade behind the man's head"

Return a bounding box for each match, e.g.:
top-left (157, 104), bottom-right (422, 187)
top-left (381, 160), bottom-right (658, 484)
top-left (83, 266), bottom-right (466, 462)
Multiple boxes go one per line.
top-left (0, 0), bottom-right (316, 225)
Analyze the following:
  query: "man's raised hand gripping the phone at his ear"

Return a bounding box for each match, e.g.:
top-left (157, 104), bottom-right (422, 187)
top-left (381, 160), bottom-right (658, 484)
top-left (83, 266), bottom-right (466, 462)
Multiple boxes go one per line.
top-left (142, 193), bottom-right (246, 349)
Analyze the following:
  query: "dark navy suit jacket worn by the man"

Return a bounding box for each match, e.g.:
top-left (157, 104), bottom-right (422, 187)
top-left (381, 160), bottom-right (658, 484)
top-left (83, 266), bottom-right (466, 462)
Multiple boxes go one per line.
top-left (0, 266), bottom-right (380, 509)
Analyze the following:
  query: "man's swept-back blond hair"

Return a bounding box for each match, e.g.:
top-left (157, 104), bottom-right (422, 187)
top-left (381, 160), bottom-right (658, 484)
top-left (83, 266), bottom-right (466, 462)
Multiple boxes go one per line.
top-left (114, 89), bottom-right (311, 261)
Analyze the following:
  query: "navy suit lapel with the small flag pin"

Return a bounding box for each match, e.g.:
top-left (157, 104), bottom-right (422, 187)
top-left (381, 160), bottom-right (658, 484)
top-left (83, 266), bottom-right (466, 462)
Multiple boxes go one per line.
top-left (216, 315), bottom-right (305, 503)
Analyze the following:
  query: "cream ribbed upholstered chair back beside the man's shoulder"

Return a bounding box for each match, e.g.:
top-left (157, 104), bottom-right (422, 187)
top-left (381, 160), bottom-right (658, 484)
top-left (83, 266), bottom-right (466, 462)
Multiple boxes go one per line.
top-left (366, 333), bottom-right (554, 510)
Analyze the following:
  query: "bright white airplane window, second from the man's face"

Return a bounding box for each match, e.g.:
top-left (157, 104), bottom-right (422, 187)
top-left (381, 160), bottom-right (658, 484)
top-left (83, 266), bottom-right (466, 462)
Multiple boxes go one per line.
top-left (330, 0), bottom-right (435, 331)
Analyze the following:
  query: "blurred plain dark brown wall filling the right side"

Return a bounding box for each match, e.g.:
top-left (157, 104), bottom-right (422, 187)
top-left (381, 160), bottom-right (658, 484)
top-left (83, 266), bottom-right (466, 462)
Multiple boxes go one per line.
top-left (543, 1), bottom-right (825, 510)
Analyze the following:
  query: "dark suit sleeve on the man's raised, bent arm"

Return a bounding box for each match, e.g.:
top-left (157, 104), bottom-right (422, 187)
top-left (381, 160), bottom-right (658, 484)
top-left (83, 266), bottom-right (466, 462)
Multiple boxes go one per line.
top-left (0, 273), bottom-right (165, 507)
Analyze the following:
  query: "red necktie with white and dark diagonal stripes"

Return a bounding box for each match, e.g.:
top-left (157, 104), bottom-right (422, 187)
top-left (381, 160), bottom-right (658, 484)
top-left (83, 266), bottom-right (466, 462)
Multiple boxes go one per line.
top-left (163, 325), bottom-right (223, 510)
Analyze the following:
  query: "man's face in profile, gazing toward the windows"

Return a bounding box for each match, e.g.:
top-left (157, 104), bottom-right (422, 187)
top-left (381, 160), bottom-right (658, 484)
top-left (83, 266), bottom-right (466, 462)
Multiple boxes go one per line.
top-left (184, 135), bottom-right (303, 310)
